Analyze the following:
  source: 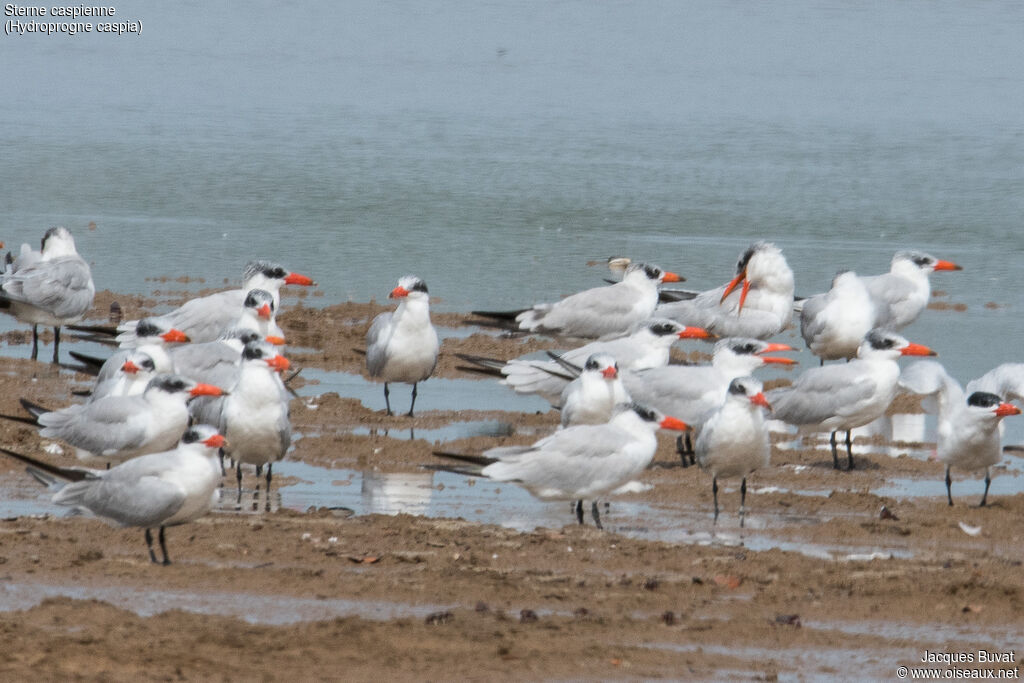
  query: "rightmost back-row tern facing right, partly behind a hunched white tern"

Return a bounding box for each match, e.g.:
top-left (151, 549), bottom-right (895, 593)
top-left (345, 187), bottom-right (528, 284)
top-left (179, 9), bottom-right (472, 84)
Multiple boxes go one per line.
top-left (863, 251), bottom-right (963, 330)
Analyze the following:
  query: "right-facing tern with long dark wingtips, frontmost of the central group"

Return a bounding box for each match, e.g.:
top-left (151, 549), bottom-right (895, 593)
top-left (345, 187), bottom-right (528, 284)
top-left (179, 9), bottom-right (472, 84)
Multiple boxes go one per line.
top-left (435, 403), bottom-right (688, 528)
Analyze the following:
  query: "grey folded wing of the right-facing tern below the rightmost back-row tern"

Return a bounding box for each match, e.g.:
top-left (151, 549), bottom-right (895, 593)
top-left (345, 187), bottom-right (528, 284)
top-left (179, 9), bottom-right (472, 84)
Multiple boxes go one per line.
top-left (768, 366), bottom-right (876, 425)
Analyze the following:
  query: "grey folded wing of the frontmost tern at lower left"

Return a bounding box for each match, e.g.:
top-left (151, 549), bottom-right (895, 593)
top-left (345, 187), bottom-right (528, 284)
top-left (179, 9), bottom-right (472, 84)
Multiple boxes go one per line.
top-left (53, 475), bottom-right (185, 527)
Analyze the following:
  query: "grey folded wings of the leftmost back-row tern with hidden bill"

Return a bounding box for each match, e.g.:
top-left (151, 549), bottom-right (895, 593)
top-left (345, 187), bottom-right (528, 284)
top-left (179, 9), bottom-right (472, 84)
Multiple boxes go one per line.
top-left (3, 256), bottom-right (95, 318)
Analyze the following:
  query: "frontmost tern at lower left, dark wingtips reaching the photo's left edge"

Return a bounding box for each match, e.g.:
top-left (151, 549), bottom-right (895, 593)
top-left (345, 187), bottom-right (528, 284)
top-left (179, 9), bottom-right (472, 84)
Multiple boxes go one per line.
top-left (0, 425), bottom-right (224, 565)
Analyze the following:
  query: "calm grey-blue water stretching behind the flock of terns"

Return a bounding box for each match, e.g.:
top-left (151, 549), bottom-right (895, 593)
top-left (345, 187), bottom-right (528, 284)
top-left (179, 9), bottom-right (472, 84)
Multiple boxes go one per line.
top-left (0, 0), bottom-right (1024, 440)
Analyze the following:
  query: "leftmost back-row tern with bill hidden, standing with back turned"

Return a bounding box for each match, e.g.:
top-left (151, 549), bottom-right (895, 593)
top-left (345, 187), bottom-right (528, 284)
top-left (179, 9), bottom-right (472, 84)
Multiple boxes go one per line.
top-left (0, 227), bottom-right (96, 362)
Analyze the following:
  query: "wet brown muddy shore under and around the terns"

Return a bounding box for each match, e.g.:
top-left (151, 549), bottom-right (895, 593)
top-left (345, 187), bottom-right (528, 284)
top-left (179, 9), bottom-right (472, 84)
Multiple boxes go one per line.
top-left (0, 292), bottom-right (1024, 680)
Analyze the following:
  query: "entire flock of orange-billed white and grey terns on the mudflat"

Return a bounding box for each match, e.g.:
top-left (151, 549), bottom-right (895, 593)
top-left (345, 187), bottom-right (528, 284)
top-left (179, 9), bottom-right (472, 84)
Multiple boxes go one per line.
top-left (0, 227), bottom-right (1024, 564)
